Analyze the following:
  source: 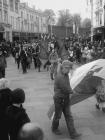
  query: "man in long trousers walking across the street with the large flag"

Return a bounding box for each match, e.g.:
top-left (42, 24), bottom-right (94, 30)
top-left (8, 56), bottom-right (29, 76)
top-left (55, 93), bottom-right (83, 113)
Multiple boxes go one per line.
top-left (52, 60), bottom-right (81, 139)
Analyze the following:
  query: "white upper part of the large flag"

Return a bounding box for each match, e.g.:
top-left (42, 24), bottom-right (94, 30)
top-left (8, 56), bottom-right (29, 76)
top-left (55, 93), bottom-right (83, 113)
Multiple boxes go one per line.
top-left (70, 59), bottom-right (105, 90)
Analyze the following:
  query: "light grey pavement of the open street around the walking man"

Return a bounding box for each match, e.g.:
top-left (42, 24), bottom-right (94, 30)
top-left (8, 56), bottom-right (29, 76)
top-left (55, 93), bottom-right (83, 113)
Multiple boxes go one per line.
top-left (6, 57), bottom-right (105, 140)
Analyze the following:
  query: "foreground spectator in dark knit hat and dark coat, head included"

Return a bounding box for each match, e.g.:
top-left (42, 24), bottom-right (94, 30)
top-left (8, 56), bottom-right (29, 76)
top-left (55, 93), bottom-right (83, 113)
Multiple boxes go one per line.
top-left (6, 88), bottom-right (30, 140)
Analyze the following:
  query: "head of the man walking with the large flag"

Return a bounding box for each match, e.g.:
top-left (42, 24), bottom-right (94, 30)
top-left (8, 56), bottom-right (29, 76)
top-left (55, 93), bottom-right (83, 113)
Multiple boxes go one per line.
top-left (61, 60), bottom-right (73, 74)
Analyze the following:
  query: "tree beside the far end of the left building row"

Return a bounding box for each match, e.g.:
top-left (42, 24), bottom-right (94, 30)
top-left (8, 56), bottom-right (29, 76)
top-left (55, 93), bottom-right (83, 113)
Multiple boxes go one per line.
top-left (43, 9), bottom-right (55, 25)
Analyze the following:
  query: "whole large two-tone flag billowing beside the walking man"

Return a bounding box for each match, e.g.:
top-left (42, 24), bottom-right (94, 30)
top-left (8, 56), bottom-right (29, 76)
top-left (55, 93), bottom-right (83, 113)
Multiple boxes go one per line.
top-left (70, 59), bottom-right (105, 105)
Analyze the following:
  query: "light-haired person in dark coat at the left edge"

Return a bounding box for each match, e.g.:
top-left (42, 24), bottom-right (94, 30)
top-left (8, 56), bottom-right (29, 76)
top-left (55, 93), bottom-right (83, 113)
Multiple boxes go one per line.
top-left (0, 78), bottom-right (12, 140)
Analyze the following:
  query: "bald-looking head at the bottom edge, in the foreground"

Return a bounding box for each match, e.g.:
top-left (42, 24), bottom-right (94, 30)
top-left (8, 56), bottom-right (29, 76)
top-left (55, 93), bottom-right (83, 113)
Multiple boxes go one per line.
top-left (18, 123), bottom-right (44, 140)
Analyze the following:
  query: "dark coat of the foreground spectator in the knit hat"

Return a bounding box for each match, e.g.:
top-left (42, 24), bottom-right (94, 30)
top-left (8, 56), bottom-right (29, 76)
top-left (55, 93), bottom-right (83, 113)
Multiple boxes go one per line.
top-left (7, 105), bottom-right (30, 140)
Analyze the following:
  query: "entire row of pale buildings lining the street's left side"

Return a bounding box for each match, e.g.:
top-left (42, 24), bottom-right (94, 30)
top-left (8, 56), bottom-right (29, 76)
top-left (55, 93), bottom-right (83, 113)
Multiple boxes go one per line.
top-left (0, 0), bottom-right (48, 41)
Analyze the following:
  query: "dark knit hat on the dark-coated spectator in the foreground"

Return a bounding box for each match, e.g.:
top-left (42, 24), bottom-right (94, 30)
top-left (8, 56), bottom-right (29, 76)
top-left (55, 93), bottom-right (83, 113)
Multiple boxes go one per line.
top-left (13, 88), bottom-right (25, 104)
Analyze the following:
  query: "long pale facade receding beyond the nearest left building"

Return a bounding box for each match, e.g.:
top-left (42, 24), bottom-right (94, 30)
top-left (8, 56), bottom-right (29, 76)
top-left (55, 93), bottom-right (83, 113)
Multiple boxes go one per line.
top-left (18, 3), bottom-right (48, 39)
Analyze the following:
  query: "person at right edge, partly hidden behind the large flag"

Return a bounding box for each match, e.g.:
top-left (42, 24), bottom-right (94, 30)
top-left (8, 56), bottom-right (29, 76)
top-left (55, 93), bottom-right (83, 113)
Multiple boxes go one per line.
top-left (96, 80), bottom-right (105, 112)
